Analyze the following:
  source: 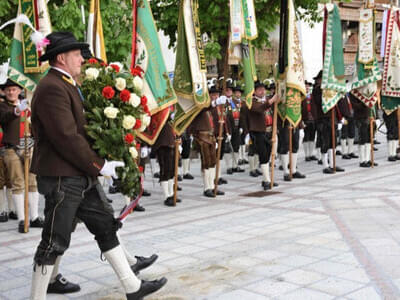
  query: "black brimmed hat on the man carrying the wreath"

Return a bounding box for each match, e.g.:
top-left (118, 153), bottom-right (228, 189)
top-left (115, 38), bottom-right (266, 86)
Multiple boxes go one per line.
top-left (39, 32), bottom-right (89, 61)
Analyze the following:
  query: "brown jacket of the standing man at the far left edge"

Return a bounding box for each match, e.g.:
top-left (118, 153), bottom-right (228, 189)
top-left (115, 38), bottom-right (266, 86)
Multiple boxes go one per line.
top-left (0, 101), bottom-right (21, 146)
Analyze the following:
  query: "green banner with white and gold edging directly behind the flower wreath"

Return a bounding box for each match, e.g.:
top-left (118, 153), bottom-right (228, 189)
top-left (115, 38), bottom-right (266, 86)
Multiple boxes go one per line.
top-left (136, 0), bottom-right (176, 115)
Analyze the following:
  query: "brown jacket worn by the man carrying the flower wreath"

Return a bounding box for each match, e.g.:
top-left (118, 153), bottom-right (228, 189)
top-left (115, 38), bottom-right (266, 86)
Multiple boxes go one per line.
top-left (31, 69), bottom-right (104, 176)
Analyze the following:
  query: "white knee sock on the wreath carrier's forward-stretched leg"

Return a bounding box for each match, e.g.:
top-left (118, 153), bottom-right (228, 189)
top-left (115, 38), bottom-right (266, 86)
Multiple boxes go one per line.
top-left (103, 246), bottom-right (141, 294)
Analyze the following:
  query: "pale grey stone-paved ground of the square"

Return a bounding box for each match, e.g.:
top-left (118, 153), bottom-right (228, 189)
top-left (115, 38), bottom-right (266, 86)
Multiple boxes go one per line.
top-left (0, 132), bottom-right (400, 300)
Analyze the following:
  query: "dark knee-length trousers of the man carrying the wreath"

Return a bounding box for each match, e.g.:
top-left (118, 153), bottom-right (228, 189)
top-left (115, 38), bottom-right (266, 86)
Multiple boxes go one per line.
top-left (34, 176), bottom-right (122, 265)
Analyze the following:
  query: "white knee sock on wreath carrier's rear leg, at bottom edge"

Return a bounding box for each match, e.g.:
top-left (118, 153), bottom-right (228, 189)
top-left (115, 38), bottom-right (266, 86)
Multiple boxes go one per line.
top-left (30, 265), bottom-right (54, 300)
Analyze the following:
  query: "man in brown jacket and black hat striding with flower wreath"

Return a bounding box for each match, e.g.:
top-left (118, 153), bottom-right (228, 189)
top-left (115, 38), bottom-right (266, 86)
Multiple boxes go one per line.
top-left (31, 32), bottom-right (166, 300)
